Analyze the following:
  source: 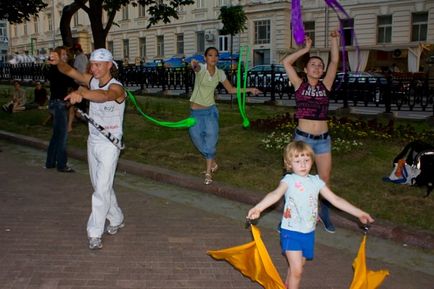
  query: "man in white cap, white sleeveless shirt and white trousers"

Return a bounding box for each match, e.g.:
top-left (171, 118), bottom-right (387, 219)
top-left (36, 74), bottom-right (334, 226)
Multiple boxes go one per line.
top-left (49, 48), bottom-right (126, 250)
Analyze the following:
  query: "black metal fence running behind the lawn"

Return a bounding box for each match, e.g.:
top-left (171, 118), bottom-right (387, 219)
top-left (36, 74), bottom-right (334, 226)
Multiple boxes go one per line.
top-left (0, 64), bottom-right (434, 116)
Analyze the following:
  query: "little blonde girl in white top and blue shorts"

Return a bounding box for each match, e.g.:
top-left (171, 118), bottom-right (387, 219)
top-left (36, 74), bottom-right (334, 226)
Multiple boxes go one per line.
top-left (247, 141), bottom-right (374, 289)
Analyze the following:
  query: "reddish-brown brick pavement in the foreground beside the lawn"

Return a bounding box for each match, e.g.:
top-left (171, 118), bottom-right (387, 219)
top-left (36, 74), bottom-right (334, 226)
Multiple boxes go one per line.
top-left (0, 141), bottom-right (434, 289)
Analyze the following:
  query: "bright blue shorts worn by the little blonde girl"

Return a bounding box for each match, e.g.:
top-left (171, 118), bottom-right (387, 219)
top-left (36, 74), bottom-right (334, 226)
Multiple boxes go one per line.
top-left (280, 228), bottom-right (315, 260)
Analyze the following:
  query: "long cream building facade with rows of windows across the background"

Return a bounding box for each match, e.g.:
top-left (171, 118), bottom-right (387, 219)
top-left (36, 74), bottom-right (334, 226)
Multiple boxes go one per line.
top-left (5, 0), bottom-right (434, 72)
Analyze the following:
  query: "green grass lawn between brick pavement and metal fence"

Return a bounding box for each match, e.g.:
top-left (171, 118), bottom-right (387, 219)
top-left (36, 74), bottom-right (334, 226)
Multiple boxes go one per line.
top-left (0, 82), bottom-right (434, 232)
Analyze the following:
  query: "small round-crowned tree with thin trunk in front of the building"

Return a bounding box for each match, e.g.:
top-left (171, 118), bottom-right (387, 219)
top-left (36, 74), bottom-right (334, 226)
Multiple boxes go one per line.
top-left (218, 5), bottom-right (247, 64)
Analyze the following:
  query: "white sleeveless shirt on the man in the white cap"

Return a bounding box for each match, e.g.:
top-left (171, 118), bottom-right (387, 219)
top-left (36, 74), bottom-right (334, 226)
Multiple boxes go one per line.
top-left (89, 78), bottom-right (125, 141)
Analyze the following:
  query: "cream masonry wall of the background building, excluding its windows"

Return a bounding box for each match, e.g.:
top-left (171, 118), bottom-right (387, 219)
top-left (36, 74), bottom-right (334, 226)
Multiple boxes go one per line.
top-left (8, 0), bottom-right (434, 70)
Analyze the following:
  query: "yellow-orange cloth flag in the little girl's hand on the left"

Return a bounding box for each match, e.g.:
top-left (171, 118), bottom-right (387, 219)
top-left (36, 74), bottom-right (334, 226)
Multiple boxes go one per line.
top-left (208, 225), bottom-right (285, 289)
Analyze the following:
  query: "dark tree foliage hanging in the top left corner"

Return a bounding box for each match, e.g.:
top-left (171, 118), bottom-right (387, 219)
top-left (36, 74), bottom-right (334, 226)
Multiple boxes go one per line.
top-left (0, 0), bottom-right (47, 24)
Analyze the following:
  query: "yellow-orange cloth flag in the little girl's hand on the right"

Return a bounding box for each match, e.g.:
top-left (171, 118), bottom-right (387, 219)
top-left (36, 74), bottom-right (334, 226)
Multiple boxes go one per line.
top-left (350, 235), bottom-right (389, 289)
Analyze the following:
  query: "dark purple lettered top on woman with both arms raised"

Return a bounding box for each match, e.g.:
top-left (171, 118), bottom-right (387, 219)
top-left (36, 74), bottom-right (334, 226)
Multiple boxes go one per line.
top-left (295, 81), bottom-right (329, 120)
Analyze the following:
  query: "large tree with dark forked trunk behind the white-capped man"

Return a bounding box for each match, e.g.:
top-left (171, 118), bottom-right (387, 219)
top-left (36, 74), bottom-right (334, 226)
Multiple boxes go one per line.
top-left (60, 0), bottom-right (194, 48)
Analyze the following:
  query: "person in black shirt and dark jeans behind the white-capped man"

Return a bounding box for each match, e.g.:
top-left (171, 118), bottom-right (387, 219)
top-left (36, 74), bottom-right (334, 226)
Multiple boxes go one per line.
top-left (45, 46), bottom-right (76, 173)
